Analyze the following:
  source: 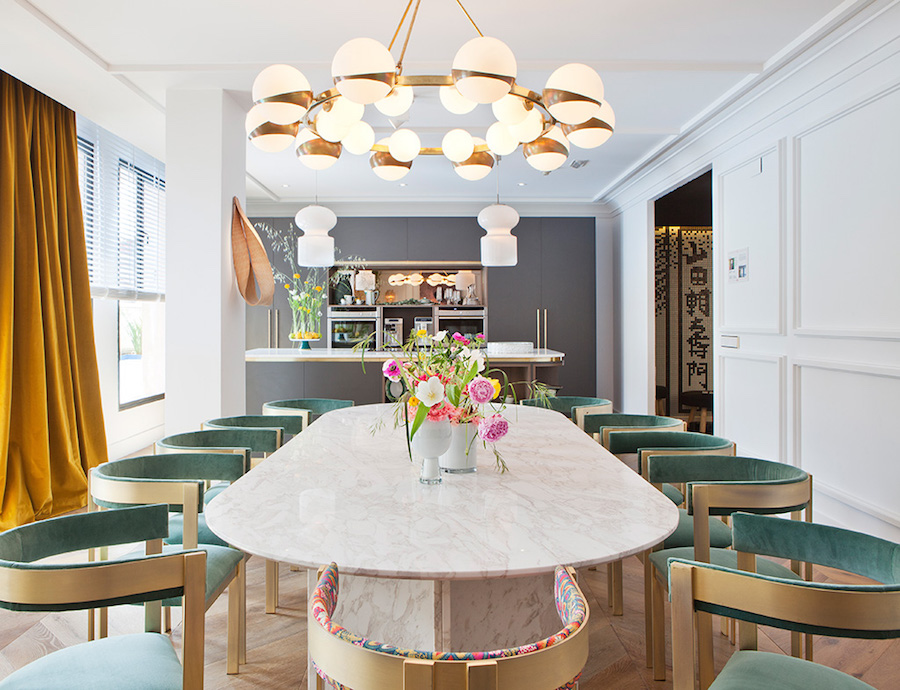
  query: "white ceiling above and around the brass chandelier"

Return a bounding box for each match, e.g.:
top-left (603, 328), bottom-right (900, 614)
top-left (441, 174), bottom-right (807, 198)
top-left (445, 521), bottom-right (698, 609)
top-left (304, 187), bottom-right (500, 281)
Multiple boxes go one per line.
top-left (0, 0), bottom-right (863, 203)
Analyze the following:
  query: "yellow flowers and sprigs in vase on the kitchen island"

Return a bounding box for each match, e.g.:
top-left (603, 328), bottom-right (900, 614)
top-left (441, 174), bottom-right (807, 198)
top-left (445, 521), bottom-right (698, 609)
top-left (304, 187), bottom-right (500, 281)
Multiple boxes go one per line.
top-left (256, 223), bottom-right (364, 340)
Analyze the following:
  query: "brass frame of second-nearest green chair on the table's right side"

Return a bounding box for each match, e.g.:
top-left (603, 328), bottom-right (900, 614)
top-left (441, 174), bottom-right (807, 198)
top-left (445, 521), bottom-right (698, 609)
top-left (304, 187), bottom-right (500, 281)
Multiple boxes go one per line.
top-left (644, 474), bottom-right (813, 680)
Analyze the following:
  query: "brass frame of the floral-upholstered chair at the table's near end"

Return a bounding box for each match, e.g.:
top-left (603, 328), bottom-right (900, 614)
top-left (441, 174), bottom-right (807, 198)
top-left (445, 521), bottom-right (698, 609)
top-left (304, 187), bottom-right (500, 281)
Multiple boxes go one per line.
top-left (307, 568), bottom-right (590, 690)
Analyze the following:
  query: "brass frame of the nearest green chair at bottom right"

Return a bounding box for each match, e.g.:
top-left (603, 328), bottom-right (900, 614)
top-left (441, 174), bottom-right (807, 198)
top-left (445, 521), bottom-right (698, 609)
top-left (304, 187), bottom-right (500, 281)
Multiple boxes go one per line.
top-left (669, 552), bottom-right (900, 690)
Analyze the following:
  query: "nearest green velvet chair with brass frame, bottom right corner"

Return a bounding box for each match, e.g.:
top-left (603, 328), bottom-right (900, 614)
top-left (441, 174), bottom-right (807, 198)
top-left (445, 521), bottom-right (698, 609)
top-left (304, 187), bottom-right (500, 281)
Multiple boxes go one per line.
top-left (669, 513), bottom-right (900, 690)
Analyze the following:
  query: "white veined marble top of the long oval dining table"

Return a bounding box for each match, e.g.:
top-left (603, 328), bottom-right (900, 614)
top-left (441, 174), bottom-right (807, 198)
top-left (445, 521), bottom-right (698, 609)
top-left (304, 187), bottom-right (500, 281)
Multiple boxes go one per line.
top-left (206, 404), bottom-right (678, 580)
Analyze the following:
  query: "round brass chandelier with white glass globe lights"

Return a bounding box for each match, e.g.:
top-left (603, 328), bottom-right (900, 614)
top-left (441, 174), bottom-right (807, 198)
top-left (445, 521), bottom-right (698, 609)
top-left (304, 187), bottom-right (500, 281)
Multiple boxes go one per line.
top-left (246, 0), bottom-right (615, 181)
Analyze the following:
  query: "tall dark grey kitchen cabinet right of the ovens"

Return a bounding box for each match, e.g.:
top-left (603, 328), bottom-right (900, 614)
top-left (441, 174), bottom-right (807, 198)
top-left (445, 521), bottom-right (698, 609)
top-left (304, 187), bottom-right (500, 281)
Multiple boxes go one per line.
top-left (488, 218), bottom-right (596, 396)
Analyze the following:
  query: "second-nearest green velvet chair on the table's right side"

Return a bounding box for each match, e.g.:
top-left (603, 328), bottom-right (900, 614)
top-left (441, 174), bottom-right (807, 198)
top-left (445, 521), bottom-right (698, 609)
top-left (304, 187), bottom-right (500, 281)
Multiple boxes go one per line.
top-left (644, 455), bottom-right (812, 680)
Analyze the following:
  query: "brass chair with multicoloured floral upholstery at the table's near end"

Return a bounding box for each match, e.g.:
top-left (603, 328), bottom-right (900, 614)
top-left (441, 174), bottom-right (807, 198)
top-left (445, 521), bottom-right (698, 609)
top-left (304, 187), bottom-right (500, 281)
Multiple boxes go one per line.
top-left (309, 563), bottom-right (589, 690)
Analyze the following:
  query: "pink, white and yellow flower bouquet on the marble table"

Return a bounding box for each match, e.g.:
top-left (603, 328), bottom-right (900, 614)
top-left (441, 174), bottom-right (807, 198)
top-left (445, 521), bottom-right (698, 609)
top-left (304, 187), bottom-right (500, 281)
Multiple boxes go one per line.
top-left (382, 330), bottom-right (509, 472)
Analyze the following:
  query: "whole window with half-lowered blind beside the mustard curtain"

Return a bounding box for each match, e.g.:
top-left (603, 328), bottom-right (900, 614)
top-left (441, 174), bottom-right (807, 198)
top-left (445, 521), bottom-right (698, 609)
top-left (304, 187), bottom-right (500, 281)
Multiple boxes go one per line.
top-left (78, 116), bottom-right (166, 409)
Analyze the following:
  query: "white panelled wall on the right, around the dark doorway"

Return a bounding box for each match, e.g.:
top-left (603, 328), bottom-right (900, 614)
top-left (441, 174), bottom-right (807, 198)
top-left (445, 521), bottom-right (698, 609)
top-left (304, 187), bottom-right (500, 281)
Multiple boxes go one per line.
top-left (606, 0), bottom-right (900, 541)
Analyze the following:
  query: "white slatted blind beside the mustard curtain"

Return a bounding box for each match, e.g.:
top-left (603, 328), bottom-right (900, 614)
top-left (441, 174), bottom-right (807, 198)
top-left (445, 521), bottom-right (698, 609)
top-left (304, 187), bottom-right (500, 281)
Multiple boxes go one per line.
top-left (77, 115), bottom-right (166, 300)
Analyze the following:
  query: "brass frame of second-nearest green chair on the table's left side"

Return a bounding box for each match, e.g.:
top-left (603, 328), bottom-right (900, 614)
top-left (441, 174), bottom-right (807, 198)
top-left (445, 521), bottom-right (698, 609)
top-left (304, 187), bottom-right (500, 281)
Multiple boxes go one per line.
top-left (88, 465), bottom-right (248, 674)
